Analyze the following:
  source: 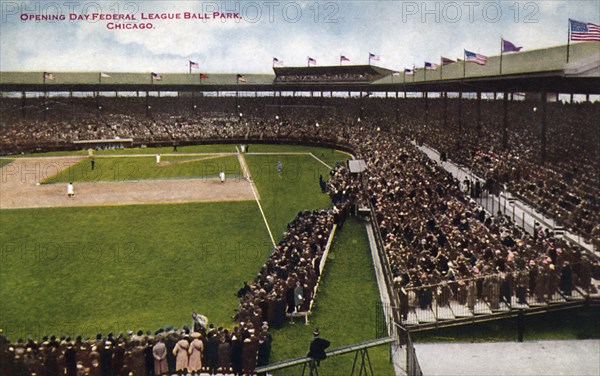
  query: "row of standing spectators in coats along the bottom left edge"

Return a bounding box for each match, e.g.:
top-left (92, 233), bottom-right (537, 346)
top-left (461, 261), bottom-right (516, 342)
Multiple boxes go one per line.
top-left (0, 322), bottom-right (273, 376)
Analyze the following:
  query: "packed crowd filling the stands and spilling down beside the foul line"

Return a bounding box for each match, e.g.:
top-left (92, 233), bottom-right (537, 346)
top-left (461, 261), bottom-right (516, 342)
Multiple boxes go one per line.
top-left (0, 94), bottom-right (600, 356)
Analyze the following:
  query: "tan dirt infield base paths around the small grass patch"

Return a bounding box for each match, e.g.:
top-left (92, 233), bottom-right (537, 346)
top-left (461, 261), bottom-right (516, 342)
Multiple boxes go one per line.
top-left (0, 157), bottom-right (254, 209)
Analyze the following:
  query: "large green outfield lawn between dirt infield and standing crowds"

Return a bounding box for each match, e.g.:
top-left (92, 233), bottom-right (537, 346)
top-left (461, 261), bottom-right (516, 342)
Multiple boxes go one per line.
top-left (0, 202), bottom-right (271, 340)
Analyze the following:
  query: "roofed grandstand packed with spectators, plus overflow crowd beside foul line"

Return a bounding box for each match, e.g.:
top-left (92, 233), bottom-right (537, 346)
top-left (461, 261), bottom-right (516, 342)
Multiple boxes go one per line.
top-left (0, 43), bottom-right (600, 369)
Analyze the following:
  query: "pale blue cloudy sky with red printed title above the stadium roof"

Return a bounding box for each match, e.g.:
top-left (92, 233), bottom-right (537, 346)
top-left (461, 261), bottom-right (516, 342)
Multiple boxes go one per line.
top-left (0, 0), bottom-right (600, 73)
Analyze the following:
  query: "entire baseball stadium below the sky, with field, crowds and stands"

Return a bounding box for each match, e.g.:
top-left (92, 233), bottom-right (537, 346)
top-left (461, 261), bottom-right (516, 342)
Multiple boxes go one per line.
top-left (0, 33), bottom-right (600, 375)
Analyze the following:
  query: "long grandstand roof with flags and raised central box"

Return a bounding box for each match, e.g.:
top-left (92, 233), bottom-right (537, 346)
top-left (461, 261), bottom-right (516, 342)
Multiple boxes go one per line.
top-left (0, 42), bottom-right (600, 94)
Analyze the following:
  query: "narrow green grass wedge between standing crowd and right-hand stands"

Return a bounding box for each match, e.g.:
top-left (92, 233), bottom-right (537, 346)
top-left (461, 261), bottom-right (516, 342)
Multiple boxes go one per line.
top-left (271, 219), bottom-right (394, 375)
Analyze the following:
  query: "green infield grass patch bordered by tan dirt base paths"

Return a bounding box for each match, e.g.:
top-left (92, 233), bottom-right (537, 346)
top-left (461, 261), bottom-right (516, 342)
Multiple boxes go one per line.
top-left (43, 155), bottom-right (242, 183)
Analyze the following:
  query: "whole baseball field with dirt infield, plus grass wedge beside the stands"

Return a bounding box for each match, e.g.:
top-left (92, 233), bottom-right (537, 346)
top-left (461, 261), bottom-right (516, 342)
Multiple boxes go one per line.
top-left (0, 145), bottom-right (391, 373)
